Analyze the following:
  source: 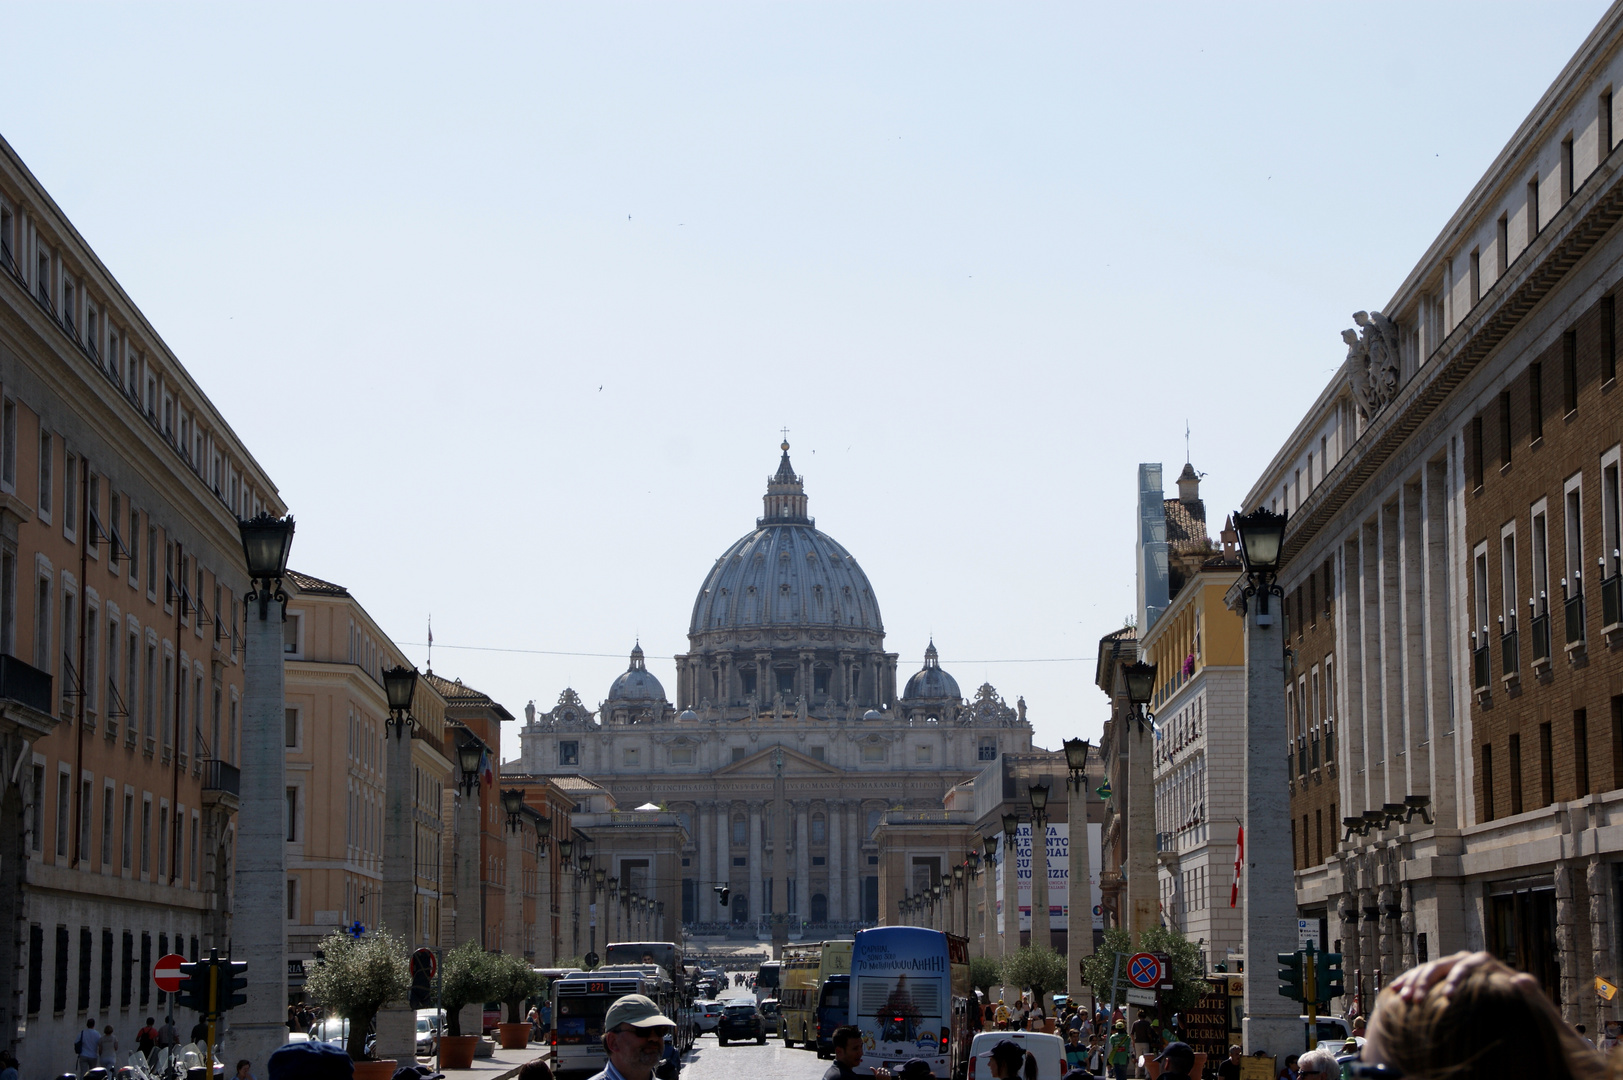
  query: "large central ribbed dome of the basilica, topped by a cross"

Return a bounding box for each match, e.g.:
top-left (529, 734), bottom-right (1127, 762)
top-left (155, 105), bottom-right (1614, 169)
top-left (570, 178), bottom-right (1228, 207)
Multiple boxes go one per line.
top-left (688, 442), bottom-right (885, 636)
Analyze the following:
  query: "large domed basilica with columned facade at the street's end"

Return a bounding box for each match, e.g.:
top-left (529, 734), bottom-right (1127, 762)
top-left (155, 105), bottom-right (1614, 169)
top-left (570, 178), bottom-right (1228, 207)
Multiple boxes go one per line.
top-left (521, 442), bottom-right (1031, 934)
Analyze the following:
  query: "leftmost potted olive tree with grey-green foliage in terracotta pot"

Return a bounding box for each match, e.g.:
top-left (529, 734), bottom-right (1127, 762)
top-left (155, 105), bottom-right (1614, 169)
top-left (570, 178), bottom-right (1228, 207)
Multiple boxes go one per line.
top-left (305, 931), bottom-right (411, 1080)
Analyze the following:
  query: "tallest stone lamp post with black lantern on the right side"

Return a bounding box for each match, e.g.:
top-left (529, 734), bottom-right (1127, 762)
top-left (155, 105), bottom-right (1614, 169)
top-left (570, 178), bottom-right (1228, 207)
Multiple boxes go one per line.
top-left (1233, 507), bottom-right (1302, 1054)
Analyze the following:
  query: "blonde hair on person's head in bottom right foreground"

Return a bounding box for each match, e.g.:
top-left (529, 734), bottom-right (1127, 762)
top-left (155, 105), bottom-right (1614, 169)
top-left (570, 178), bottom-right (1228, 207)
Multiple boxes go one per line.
top-left (1363, 953), bottom-right (1604, 1080)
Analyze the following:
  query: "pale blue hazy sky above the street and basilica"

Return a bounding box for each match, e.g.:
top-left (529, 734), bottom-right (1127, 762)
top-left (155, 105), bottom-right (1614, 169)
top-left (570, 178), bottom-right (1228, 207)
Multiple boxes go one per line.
top-left (0, 0), bottom-right (1605, 758)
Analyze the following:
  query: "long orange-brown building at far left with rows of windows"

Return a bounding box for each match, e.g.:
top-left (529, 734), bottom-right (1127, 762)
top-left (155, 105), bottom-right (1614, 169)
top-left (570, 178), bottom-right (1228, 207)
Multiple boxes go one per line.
top-left (0, 132), bottom-right (284, 1072)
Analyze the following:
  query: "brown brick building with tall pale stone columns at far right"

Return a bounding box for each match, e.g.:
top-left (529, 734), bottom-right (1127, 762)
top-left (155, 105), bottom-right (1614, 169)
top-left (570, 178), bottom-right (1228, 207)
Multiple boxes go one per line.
top-left (1245, 6), bottom-right (1623, 1030)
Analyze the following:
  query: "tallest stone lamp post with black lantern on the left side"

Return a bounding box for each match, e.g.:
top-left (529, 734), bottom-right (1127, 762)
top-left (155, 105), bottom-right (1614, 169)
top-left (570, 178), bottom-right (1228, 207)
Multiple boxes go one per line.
top-left (230, 513), bottom-right (294, 1061)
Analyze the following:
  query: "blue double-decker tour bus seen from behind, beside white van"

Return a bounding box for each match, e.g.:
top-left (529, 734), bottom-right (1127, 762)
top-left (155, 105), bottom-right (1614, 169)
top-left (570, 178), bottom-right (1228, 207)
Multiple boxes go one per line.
top-left (850, 926), bottom-right (972, 1077)
